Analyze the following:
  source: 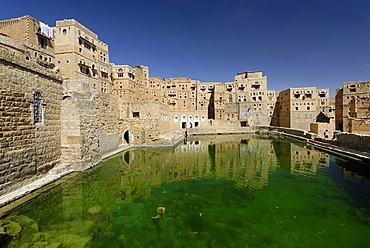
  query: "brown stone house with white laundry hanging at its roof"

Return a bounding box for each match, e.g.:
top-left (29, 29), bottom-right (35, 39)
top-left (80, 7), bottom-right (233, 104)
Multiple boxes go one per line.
top-left (0, 16), bottom-right (55, 69)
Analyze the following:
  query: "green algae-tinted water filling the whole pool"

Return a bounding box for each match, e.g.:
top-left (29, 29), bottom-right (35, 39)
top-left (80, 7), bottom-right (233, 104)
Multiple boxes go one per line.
top-left (0, 135), bottom-right (370, 247)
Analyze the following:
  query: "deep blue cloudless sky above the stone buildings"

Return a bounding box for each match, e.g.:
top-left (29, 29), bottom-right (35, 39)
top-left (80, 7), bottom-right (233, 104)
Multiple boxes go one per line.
top-left (0, 0), bottom-right (370, 96)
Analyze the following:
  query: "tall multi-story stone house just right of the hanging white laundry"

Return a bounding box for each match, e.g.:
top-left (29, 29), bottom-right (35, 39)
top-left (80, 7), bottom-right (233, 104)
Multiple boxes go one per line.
top-left (54, 19), bottom-right (112, 93)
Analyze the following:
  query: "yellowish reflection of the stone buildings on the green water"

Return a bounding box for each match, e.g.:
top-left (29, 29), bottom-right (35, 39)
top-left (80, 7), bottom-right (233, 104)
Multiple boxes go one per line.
top-left (4, 134), bottom-right (370, 247)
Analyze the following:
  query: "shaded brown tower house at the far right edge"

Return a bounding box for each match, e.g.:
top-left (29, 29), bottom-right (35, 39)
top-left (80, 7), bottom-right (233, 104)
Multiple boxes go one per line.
top-left (335, 82), bottom-right (370, 133)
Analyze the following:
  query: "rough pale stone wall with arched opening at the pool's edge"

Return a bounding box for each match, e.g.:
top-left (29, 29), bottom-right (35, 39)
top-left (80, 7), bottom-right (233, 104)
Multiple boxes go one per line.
top-left (61, 80), bottom-right (179, 168)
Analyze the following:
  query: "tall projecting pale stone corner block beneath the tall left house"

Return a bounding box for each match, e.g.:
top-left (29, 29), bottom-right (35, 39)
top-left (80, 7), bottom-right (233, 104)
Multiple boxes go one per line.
top-left (61, 80), bottom-right (101, 166)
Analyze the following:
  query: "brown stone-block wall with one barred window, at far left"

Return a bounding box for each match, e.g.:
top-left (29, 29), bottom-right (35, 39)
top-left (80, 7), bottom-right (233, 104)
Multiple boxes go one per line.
top-left (0, 45), bottom-right (62, 195)
